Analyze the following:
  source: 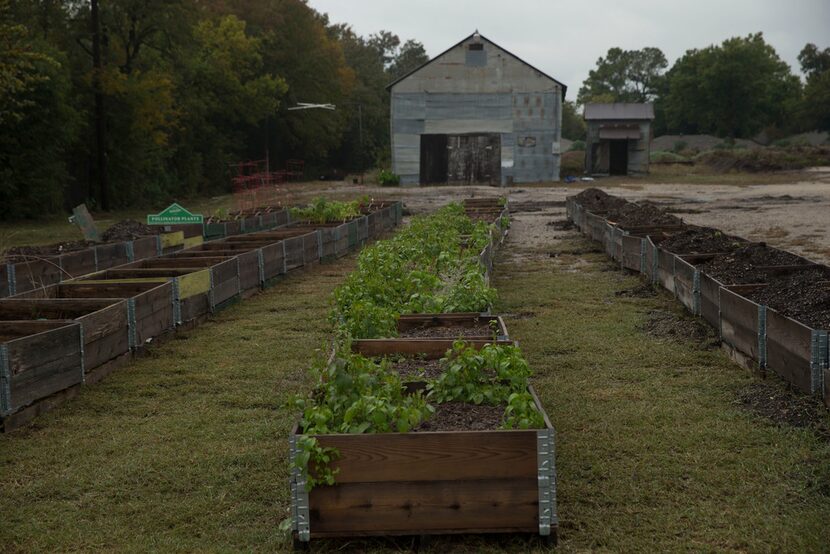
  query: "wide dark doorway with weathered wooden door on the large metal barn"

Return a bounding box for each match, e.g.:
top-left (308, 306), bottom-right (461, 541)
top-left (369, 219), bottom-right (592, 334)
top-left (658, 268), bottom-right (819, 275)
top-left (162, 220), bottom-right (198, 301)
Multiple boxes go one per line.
top-left (420, 133), bottom-right (501, 185)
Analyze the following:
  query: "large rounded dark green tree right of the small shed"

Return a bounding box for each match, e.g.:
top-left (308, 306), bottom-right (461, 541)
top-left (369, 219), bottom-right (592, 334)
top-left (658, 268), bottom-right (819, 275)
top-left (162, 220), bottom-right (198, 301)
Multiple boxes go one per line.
top-left (665, 33), bottom-right (800, 137)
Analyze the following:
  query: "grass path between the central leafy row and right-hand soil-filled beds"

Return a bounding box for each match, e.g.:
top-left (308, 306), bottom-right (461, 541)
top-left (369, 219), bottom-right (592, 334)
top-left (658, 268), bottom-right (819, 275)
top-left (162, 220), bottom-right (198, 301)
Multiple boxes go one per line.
top-left (495, 227), bottom-right (830, 552)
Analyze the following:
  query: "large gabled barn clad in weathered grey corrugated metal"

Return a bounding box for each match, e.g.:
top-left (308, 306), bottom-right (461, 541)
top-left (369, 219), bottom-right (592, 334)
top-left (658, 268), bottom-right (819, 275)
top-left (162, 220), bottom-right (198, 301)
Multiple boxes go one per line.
top-left (388, 32), bottom-right (567, 186)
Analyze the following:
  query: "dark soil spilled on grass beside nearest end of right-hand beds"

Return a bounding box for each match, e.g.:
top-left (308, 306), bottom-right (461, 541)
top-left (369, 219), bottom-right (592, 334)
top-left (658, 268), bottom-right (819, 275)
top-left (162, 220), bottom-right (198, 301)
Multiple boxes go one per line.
top-left (737, 382), bottom-right (830, 440)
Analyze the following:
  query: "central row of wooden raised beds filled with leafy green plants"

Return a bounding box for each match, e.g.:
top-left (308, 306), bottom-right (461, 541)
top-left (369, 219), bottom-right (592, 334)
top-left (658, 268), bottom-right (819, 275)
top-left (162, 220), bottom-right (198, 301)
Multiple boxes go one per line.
top-left (287, 199), bottom-right (557, 546)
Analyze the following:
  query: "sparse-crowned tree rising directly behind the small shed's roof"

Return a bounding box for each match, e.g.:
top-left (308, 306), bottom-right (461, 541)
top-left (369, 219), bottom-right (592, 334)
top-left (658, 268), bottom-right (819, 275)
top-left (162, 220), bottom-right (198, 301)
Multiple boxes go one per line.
top-left (577, 47), bottom-right (668, 105)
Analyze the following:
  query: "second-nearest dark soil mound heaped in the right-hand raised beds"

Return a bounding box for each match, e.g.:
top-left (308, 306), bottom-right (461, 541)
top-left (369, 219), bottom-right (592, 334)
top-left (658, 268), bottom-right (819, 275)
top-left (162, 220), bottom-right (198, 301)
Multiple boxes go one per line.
top-left (698, 242), bottom-right (805, 285)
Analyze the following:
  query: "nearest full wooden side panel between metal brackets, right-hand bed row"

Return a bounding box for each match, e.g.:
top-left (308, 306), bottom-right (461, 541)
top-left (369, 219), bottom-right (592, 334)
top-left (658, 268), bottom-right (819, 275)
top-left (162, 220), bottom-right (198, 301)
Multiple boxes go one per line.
top-left (767, 308), bottom-right (812, 394)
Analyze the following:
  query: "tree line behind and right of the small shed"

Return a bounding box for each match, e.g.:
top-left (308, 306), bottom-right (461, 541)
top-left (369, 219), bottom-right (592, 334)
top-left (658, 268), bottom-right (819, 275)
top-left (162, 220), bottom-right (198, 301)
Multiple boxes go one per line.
top-left (563, 33), bottom-right (830, 140)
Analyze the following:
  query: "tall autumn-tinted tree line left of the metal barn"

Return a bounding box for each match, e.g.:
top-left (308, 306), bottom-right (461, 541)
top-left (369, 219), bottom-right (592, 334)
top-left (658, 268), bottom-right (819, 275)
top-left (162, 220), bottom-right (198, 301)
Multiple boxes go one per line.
top-left (0, 0), bottom-right (427, 218)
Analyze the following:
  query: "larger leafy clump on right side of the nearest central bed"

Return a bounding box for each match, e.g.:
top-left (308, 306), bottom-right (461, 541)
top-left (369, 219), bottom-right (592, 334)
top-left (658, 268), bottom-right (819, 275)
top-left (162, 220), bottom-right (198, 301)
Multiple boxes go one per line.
top-left (427, 341), bottom-right (531, 405)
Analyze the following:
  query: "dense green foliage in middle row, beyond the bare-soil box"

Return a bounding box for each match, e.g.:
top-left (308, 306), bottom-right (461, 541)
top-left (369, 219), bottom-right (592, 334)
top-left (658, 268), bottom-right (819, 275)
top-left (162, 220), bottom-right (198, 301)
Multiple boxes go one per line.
top-left (332, 204), bottom-right (495, 338)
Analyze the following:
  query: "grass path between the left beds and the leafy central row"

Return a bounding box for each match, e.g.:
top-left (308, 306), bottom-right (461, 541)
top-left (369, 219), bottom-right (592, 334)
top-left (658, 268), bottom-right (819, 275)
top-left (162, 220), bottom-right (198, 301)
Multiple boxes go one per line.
top-left (0, 256), bottom-right (354, 552)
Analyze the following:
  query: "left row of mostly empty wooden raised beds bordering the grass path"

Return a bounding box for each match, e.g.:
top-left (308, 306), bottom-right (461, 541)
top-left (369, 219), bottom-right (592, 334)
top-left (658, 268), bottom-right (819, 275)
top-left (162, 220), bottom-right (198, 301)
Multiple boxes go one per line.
top-left (0, 196), bottom-right (401, 430)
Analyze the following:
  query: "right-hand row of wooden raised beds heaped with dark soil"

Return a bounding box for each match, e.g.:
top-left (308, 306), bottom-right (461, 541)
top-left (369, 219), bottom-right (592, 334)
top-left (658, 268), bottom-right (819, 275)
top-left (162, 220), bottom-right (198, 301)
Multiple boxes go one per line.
top-left (567, 189), bottom-right (830, 406)
